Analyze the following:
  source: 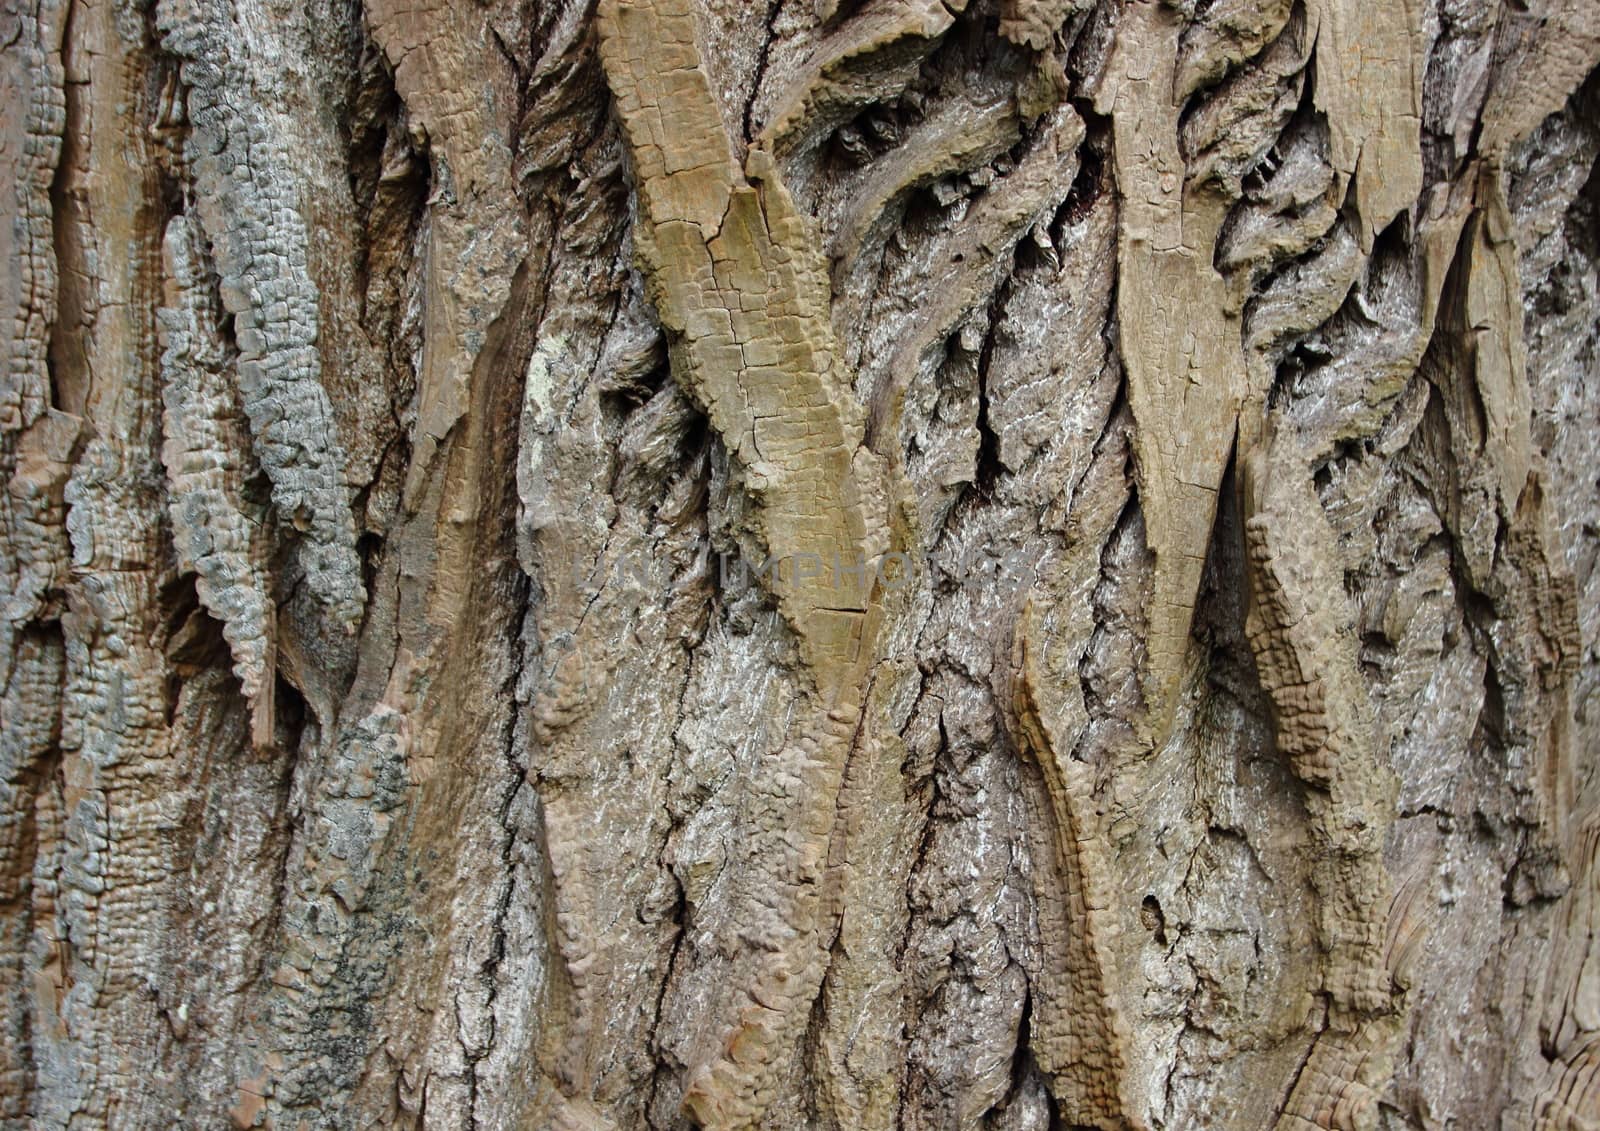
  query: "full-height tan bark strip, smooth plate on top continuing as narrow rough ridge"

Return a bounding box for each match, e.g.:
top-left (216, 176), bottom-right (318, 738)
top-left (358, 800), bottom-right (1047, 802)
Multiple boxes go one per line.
top-left (598, 0), bottom-right (890, 1128)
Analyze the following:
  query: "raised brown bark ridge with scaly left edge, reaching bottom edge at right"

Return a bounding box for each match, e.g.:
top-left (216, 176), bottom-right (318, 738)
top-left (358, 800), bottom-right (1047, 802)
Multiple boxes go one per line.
top-left (1242, 426), bottom-right (1400, 1131)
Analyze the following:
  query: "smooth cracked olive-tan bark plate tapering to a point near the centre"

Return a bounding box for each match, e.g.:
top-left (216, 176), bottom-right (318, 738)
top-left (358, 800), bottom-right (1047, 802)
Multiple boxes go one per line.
top-left (598, 0), bottom-right (888, 678)
